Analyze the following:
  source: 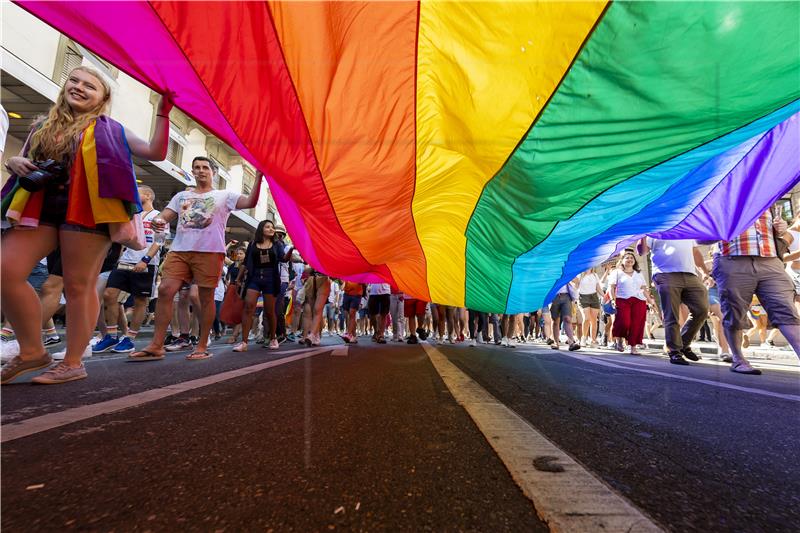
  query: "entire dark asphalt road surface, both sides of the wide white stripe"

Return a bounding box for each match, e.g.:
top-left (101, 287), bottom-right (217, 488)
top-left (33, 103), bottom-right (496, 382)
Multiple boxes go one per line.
top-left (0, 339), bottom-right (800, 532)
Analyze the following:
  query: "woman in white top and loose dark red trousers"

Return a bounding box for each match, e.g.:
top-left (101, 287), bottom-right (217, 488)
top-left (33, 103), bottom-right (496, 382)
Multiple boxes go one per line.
top-left (608, 251), bottom-right (651, 355)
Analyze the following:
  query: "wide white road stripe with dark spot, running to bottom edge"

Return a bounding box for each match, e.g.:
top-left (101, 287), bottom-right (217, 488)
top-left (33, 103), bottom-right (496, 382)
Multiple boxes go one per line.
top-left (422, 343), bottom-right (662, 532)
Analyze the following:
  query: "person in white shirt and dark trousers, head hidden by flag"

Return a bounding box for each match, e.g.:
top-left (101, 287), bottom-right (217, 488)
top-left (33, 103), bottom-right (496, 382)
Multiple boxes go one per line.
top-left (640, 237), bottom-right (708, 365)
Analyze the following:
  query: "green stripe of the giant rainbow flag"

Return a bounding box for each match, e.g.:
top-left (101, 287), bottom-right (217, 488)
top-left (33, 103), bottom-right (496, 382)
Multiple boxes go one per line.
top-left (466, 2), bottom-right (800, 310)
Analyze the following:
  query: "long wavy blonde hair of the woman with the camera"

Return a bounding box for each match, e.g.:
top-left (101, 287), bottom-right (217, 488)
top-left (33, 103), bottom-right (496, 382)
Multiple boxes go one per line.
top-left (28, 66), bottom-right (111, 161)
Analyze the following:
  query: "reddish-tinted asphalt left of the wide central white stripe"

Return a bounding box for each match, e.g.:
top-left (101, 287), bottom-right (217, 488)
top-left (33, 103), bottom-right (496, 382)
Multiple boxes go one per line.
top-left (2, 338), bottom-right (547, 532)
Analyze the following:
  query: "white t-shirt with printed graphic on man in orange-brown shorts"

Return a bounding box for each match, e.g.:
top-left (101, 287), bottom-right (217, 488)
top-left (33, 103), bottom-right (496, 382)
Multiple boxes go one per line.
top-left (167, 191), bottom-right (241, 254)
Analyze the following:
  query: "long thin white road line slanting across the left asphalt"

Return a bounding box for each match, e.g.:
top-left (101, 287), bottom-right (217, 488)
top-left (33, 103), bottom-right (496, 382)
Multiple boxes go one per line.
top-left (0, 347), bottom-right (331, 442)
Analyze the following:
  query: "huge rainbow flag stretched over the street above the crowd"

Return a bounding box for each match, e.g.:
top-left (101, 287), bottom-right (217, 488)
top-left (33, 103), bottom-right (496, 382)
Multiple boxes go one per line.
top-left (18, 0), bottom-right (800, 312)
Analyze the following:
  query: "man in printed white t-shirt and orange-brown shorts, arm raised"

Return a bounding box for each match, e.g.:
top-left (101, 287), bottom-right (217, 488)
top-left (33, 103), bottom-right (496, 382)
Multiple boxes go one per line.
top-left (129, 157), bottom-right (264, 361)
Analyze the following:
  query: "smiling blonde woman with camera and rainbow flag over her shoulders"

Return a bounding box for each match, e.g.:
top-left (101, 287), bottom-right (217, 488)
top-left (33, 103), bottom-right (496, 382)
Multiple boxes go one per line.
top-left (0, 66), bottom-right (172, 384)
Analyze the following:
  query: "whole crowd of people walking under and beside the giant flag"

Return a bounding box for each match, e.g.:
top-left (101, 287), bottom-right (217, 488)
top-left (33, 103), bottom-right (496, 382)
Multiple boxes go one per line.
top-left (1, 67), bottom-right (800, 384)
